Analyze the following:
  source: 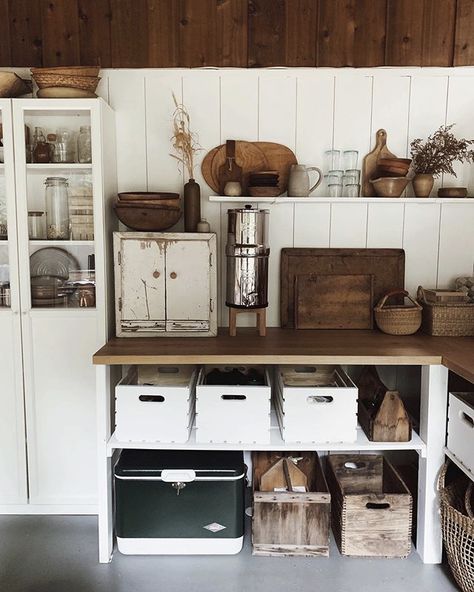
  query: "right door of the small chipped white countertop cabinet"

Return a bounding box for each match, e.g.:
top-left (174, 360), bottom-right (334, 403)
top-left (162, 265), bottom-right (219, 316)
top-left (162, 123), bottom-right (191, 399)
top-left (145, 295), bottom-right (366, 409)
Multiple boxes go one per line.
top-left (166, 239), bottom-right (211, 331)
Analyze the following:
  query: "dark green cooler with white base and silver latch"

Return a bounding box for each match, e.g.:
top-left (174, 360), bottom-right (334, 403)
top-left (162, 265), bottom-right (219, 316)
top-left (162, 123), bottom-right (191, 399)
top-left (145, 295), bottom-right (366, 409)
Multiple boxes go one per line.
top-left (114, 450), bottom-right (245, 555)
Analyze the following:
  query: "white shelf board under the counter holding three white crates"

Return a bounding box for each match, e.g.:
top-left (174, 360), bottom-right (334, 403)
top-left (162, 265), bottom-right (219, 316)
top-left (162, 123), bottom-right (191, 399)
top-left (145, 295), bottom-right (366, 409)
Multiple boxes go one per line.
top-left (107, 411), bottom-right (426, 457)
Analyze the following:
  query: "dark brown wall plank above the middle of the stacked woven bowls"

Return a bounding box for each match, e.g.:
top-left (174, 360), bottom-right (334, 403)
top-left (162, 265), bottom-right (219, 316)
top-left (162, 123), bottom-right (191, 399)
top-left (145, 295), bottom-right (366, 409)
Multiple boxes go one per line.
top-left (41, 0), bottom-right (80, 66)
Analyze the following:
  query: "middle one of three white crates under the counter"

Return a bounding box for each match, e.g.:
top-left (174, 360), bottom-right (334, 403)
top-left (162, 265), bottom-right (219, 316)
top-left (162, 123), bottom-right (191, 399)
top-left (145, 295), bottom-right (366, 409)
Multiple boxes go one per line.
top-left (196, 367), bottom-right (271, 444)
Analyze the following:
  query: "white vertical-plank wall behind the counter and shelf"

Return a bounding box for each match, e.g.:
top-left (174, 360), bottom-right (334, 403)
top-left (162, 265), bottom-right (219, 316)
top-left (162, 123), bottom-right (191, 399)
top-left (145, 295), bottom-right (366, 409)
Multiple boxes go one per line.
top-left (94, 68), bottom-right (474, 325)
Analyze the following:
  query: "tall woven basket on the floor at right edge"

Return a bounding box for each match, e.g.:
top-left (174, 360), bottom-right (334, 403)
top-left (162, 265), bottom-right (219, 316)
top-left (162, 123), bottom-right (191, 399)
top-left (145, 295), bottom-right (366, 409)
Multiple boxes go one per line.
top-left (438, 461), bottom-right (474, 592)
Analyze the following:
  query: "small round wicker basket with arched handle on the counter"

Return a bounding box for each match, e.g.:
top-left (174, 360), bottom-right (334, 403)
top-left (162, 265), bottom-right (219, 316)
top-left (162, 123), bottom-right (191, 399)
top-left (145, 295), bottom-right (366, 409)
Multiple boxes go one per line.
top-left (374, 290), bottom-right (422, 335)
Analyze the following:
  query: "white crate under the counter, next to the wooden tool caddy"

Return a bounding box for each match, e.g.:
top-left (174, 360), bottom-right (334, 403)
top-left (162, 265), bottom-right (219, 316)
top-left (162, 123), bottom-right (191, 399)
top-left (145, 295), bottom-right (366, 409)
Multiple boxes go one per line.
top-left (274, 366), bottom-right (358, 443)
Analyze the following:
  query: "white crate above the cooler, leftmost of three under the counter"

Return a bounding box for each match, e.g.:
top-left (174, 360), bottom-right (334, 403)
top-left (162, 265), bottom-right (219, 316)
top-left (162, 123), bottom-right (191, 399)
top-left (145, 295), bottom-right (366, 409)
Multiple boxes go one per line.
top-left (115, 366), bottom-right (198, 443)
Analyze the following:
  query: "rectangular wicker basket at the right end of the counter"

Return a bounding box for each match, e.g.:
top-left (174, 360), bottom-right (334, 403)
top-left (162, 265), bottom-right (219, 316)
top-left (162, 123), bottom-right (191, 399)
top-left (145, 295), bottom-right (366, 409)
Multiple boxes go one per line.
top-left (417, 286), bottom-right (474, 337)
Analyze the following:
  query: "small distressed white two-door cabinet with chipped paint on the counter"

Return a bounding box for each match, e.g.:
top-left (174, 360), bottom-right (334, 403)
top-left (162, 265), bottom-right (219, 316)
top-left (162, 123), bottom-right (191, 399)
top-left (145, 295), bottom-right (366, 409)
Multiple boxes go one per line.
top-left (114, 232), bottom-right (217, 337)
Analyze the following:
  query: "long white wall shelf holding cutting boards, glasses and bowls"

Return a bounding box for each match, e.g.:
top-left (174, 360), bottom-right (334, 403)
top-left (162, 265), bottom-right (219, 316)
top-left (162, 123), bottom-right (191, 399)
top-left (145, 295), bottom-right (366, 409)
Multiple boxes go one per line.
top-left (209, 195), bottom-right (474, 204)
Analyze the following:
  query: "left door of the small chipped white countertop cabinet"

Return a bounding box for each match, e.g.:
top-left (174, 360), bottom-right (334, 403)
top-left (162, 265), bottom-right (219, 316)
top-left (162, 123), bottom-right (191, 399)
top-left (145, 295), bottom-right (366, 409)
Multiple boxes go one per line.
top-left (119, 238), bottom-right (166, 333)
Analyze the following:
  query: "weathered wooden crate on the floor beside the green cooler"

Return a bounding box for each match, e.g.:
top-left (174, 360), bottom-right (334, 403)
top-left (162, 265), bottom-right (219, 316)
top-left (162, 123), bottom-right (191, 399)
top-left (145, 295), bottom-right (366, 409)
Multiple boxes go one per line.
top-left (252, 452), bottom-right (331, 556)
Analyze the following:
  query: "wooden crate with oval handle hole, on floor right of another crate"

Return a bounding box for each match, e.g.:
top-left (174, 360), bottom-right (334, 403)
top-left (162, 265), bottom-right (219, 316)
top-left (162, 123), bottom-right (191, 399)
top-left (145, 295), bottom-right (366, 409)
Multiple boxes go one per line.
top-left (327, 454), bottom-right (412, 557)
